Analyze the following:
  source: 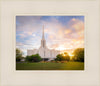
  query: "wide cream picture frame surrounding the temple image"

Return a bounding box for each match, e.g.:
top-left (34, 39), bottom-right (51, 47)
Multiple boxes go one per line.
top-left (0, 0), bottom-right (100, 86)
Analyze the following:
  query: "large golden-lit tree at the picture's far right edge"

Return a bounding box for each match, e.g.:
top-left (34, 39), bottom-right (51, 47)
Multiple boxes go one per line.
top-left (73, 48), bottom-right (84, 62)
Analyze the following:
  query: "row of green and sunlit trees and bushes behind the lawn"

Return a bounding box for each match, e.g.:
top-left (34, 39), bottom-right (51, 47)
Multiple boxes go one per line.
top-left (16, 48), bottom-right (84, 62)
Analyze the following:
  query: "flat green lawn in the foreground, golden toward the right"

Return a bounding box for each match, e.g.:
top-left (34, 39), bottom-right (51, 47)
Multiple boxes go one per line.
top-left (16, 62), bottom-right (84, 70)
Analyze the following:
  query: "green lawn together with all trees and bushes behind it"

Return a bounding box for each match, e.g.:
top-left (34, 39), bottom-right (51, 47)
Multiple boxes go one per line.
top-left (16, 48), bottom-right (84, 70)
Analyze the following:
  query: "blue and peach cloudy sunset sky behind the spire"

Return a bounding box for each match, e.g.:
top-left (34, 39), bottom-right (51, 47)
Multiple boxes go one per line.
top-left (16, 16), bottom-right (84, 56)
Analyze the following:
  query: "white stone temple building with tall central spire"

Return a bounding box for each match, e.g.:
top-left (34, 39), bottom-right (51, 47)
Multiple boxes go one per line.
top-left (27, 25), bottom-right (60, 60)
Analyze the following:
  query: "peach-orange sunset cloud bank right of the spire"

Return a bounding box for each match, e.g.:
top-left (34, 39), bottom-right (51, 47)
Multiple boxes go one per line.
top-left (42, 18), bottom-right (84, 52)
